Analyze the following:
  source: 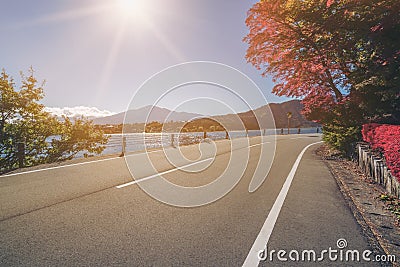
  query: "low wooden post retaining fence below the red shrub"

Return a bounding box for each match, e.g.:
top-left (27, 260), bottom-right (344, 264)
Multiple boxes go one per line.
top-left (357, 143), bottom-right (400, 198)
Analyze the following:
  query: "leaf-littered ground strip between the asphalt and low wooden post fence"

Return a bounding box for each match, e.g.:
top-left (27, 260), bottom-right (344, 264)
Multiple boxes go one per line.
top-left (317, 146), bottom-right (400, 266)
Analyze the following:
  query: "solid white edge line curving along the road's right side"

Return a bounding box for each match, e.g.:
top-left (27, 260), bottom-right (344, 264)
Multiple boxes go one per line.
top-left (242, 141), bottom-right (322, 267)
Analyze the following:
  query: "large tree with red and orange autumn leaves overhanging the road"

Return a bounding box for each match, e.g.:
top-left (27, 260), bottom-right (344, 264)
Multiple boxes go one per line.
top-left (244, 0), bottom-right (400, 154)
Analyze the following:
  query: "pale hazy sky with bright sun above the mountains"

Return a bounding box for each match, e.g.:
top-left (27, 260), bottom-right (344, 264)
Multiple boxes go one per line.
top-left (0, 0), bottom-right (289, 115)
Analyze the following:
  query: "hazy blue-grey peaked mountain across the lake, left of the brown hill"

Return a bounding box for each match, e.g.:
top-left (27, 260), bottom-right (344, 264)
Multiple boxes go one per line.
top-left (93, 106), bottom-right (202, 124)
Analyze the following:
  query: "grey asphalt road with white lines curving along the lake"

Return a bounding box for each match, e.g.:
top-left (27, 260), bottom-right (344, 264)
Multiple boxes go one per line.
top-left (0, 135), bottom-right (379, 266)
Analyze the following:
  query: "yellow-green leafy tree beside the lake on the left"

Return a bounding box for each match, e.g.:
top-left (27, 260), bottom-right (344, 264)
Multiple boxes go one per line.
top-left (0, 68), bottom-right (107, 172)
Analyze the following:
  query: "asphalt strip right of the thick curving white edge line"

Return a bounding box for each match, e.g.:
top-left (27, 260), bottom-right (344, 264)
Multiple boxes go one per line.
top-left (260, 146), bottom-right (382, 266)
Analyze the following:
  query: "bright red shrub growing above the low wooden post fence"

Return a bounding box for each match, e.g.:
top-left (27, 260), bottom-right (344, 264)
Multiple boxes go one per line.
top-left (362, 123), bottom-right (400, 181)
